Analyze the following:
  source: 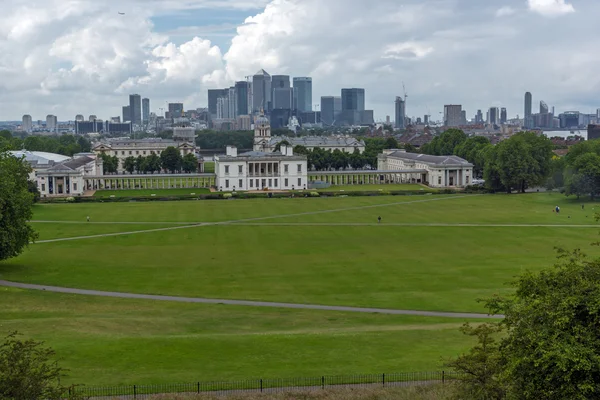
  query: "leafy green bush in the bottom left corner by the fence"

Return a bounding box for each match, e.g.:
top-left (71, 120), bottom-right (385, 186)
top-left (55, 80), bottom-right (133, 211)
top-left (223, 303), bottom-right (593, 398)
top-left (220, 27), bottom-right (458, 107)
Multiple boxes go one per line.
top-left (0, 332), bottom-right (78, 400)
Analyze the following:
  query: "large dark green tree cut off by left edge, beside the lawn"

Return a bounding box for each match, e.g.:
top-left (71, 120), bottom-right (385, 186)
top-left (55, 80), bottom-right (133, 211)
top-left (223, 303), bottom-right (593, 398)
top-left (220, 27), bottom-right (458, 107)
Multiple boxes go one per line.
top-left (0, 153), bottom-right (37, 260)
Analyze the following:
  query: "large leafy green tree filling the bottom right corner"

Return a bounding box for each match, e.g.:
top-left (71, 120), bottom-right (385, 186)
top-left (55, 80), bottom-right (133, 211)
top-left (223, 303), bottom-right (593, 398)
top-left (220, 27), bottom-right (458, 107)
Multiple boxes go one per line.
top-left (486, 250), bottom-right (600, 400)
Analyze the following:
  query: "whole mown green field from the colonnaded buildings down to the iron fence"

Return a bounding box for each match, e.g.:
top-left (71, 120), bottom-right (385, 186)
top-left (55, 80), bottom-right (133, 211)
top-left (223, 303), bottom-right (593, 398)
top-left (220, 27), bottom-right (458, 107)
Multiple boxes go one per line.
top-left (0, 193), bottom-right (600, 384)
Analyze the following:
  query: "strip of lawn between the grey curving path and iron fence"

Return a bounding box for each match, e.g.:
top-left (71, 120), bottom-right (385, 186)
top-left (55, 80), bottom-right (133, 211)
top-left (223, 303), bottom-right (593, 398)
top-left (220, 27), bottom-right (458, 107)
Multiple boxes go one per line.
top-left (0, 288), bottom-right (478, 385)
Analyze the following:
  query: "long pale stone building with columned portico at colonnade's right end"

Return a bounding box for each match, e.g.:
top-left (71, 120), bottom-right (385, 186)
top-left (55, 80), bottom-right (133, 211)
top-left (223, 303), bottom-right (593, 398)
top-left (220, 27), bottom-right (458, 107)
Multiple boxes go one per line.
top-left (377, 149), bottom-right (473, 188)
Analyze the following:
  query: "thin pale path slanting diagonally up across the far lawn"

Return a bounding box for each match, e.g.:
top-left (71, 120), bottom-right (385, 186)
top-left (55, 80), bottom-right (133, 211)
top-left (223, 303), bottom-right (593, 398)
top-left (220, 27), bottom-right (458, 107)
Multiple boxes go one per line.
top-left (35, 195), bottom-right (481, 244)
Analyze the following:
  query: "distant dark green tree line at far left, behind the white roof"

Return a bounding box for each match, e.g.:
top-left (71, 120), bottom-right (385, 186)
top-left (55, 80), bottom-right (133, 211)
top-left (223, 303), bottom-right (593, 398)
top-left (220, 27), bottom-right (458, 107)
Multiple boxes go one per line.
top-left (0, 130), bottom-right (92, 157)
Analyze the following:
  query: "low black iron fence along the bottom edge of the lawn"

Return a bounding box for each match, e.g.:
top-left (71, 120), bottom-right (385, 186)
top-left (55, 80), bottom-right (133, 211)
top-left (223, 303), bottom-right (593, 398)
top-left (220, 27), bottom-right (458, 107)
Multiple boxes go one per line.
top-left (71, 371), bottom-right (460, 399)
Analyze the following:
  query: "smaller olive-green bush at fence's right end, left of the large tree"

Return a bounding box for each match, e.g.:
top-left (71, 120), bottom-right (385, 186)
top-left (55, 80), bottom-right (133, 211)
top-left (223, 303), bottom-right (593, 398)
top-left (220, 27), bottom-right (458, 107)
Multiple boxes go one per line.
top-left (447, 323), bottom-right (506, 400)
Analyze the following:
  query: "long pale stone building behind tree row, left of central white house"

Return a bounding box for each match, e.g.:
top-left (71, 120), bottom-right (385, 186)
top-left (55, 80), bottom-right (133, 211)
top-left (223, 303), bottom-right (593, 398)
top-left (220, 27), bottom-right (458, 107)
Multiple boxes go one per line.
top-left (92, 138), bottom-right (204, 174)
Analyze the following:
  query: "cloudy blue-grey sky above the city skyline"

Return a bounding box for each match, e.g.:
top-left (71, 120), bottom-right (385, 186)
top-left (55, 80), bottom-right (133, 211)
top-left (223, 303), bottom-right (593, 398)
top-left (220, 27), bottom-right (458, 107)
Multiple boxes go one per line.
top-left (0, 0), bottom-right (600, 121)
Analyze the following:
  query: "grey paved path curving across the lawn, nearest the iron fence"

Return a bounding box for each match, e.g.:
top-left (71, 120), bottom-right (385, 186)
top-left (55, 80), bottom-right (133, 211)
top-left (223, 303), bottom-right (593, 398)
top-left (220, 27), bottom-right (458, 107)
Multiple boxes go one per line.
top-left (0, 280), bottom-right (504, 319)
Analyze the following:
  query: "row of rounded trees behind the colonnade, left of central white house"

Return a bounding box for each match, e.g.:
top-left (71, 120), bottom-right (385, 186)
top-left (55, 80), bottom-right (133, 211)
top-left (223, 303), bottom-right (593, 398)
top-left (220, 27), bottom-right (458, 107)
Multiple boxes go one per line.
top-left (101, 146), bottom-right (198, 174)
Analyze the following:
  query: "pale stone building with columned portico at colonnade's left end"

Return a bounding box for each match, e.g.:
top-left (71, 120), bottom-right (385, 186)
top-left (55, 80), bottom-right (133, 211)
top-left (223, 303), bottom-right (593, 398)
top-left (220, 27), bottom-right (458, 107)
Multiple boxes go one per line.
top-left (35, 153), bottom-right (103, 197)
